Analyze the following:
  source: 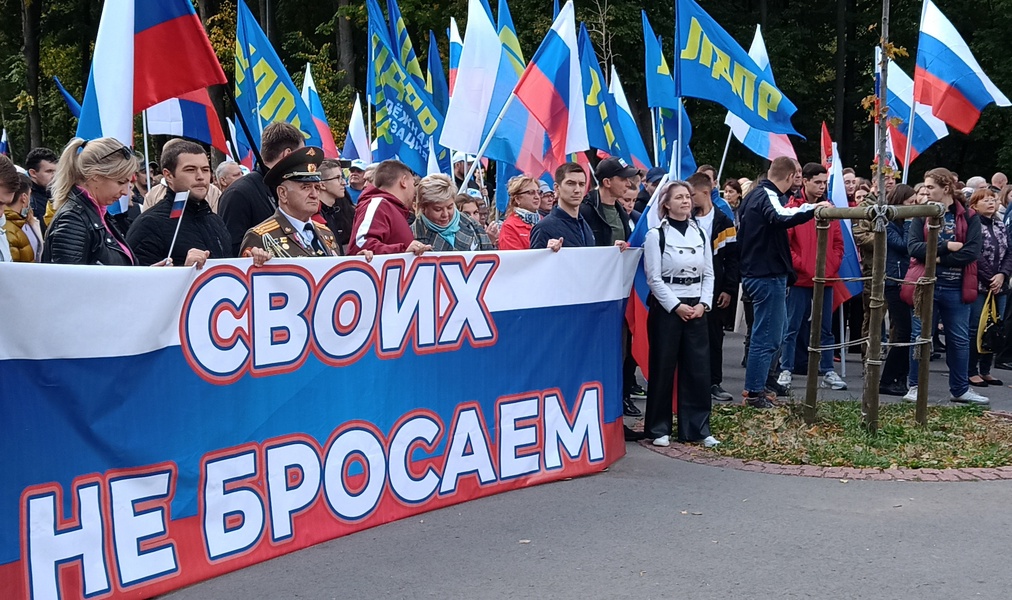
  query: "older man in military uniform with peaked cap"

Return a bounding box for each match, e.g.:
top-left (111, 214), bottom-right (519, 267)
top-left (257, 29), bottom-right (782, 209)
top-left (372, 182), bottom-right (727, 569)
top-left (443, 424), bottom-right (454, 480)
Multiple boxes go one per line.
top-left (240, 146), bottom-right (341, 258)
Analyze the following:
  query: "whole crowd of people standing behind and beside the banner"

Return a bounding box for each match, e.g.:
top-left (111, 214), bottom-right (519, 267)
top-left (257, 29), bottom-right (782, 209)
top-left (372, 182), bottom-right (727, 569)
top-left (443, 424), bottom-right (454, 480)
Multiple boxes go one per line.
top-left (0, 122), bottom-right (1012, 446)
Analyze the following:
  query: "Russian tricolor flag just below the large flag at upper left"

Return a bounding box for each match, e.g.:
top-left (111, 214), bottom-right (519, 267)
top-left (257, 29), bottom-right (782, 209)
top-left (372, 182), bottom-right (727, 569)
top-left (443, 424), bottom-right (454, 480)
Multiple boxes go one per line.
top-left (148, 88), bottom-right (230, 154)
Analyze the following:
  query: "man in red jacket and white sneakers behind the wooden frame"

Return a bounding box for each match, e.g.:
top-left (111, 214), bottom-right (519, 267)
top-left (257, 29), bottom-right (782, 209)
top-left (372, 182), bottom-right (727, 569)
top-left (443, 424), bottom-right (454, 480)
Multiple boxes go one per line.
top-left (777, 163), bottom-right (847, 390)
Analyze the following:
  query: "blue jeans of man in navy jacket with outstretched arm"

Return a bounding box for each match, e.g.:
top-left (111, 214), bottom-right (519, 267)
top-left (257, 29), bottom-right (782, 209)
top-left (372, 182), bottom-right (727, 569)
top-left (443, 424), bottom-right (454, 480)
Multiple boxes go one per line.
top-left (742, 275), bottom-right (787, 393)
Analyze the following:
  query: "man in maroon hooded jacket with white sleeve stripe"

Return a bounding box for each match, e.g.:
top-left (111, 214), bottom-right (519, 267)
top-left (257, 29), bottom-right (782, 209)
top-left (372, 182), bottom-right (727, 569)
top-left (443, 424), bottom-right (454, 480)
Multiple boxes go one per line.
top-left (348, 160), bottom-right (432, 256)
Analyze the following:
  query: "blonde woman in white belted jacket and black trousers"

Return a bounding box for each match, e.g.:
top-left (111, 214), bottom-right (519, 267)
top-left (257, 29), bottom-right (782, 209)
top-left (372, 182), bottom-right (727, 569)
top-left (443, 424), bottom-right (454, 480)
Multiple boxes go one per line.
top-left (644, 181), bottom-right (720, 447)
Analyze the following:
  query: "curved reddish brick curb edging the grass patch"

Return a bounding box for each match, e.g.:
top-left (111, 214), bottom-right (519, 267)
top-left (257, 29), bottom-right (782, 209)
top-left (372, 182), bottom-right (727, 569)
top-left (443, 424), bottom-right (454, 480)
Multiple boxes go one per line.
top-left (640, 411), bottom-right (1012, 482)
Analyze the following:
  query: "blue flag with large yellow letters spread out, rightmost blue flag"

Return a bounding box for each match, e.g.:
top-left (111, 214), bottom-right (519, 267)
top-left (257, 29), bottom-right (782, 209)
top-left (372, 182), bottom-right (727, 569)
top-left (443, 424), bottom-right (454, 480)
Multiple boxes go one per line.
top-left (675, 0), bottom-right (804, 138)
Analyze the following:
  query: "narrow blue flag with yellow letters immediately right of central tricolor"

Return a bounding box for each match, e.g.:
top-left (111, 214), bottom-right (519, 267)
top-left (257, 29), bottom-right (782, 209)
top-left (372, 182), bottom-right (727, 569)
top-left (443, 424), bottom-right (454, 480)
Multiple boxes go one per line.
top-left (577, 23), bottom-right (633, 164)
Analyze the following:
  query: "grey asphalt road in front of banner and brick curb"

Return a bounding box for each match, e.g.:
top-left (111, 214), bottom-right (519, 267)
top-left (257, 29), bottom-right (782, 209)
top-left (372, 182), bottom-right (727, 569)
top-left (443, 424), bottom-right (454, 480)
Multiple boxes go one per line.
top-left (166, 338), bottom-right (1012, 600)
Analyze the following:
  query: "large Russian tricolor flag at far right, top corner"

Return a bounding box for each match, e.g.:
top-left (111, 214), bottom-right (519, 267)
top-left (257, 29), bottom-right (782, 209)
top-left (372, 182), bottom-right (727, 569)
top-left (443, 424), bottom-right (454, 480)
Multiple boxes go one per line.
top-left (914, 0), bottom-right (1012, 137)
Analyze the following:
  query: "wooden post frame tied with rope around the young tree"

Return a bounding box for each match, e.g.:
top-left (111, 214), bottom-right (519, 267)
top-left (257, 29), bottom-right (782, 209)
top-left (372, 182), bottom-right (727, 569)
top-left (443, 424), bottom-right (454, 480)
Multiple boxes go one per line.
top-left (805, 203), bottom-right (945, 433)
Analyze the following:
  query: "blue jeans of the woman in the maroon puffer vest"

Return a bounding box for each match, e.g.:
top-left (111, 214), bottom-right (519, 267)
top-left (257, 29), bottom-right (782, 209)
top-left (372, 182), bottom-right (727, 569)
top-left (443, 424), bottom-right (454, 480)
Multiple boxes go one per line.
top-left (907, 287), bottom-right (971, 396)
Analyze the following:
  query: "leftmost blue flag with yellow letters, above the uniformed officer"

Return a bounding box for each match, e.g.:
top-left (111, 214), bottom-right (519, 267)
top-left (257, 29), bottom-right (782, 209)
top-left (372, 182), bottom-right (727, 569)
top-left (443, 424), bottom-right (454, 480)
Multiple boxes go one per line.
top-left (236, 0), bottom-right (323, 148)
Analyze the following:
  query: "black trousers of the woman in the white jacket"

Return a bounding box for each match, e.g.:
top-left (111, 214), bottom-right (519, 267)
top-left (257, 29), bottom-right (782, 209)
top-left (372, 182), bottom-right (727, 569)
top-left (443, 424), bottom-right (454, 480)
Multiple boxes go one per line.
top-left (643, 301), bottom-right (710, 441)
